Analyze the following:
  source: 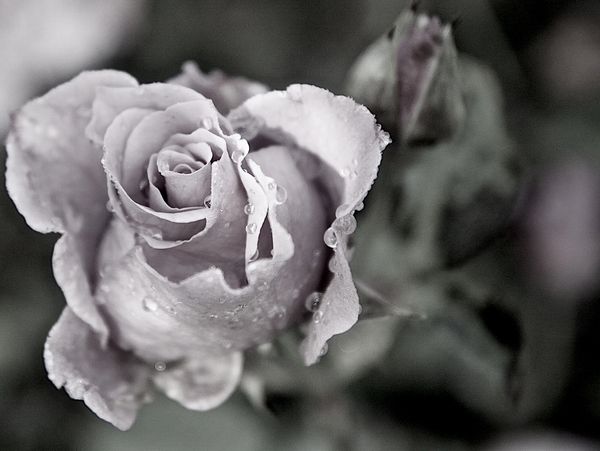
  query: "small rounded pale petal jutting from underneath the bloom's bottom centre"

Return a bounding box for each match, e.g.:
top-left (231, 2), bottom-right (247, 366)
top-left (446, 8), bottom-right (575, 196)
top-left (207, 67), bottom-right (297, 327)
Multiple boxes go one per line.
top-left (154, 352), bottom-right (243, 410)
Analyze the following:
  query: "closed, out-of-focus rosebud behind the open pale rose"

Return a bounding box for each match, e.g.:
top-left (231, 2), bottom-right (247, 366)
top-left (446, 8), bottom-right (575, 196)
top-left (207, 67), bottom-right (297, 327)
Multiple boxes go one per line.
top-left (346, 9), bottom-right (465, 143)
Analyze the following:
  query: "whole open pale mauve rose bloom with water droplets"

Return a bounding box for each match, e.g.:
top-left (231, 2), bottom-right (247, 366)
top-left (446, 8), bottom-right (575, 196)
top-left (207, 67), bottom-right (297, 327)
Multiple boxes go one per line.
top-left (7, 64), bottom-right (389, 429)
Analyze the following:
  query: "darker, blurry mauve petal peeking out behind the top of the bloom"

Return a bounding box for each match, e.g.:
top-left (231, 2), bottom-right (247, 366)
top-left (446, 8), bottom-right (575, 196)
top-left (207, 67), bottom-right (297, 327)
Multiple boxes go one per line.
top-left (168, 61), bottom-right (268, 114)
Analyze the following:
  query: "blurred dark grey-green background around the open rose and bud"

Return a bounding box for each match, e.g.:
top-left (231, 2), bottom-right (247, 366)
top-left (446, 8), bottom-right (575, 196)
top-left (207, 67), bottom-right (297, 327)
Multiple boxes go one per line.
top-left (0, 0), bottom-right (600, 451)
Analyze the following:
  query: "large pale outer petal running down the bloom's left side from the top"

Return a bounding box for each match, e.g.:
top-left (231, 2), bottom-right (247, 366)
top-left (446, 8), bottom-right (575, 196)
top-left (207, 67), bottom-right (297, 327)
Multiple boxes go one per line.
top-left (6, 71), bottom-right (135, 339)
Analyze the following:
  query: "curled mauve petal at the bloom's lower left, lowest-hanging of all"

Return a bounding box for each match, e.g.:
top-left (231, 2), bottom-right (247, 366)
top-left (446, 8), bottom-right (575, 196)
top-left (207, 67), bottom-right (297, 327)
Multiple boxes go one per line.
top-left (44, 307), bottom-right (149, 430)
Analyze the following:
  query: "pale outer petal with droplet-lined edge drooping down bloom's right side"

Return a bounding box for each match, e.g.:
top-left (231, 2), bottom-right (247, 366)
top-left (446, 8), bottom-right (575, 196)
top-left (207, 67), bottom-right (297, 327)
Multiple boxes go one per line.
top-left (229, 85), bottom-right (390, 364)
